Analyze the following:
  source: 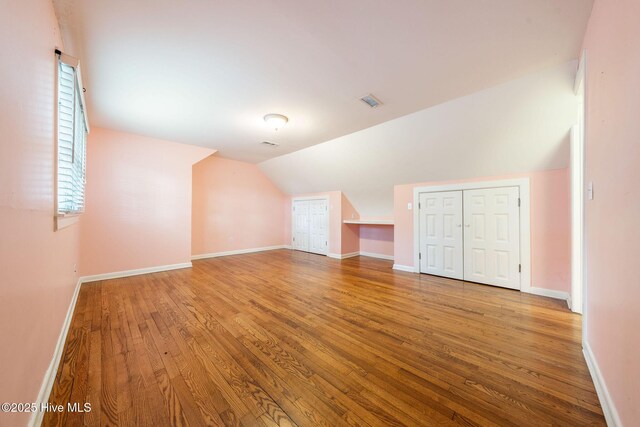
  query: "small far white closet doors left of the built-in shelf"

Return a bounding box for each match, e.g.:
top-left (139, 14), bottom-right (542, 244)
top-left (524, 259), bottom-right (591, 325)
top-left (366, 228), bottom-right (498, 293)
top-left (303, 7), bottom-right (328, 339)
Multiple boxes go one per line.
top-left (292, 199), bottom-right (329, 255)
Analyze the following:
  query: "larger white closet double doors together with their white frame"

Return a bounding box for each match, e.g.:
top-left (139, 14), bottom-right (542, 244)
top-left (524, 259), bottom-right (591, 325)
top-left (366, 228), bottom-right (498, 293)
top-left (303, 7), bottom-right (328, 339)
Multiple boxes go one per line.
top-left (413, 178), bottom-right (536, 293)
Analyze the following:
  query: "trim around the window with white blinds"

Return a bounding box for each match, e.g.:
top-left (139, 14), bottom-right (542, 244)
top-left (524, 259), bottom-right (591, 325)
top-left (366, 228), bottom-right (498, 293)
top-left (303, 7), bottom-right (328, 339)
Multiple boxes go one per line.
top-left (53, 48), bottom-right (90, 230)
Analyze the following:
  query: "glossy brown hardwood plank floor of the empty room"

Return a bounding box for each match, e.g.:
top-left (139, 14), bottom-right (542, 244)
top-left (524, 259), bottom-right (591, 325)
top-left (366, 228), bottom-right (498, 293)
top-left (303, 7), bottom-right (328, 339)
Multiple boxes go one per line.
top-left (44, 250), bottom-right (604, 426)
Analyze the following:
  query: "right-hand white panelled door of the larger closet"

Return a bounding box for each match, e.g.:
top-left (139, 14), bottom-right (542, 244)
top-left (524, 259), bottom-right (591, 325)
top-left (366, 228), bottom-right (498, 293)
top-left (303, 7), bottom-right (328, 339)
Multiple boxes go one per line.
top-left (464, 187), bottom-right (520, 289)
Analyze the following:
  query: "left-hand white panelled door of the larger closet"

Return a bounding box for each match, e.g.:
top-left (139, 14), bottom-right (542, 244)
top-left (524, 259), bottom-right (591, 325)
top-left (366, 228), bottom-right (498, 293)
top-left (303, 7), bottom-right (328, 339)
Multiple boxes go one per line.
top-left (419, 191), bottom-right (464, 279)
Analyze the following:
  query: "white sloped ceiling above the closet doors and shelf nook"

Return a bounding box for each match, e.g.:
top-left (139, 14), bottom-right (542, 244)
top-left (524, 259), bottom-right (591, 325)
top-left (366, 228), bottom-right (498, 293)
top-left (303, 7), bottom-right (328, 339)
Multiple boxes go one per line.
top-left (259, 61), bottom-right (579, 216)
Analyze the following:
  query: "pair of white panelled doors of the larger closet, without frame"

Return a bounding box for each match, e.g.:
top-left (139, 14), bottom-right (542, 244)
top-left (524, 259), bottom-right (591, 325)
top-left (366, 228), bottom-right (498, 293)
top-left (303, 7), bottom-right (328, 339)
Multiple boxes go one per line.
top-left (418, 186), bottom-right (521, 289)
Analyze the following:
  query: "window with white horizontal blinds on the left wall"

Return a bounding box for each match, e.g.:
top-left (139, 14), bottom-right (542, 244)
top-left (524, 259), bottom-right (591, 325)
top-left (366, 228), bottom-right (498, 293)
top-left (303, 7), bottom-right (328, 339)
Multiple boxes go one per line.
top-left (56, 51), bottom-right (89, 224)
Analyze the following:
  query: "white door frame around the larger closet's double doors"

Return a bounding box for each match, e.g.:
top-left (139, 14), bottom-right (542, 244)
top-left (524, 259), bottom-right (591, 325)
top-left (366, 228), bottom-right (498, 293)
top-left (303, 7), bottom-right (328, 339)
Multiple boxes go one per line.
top-left (413, 178), bottom-right (535, 293)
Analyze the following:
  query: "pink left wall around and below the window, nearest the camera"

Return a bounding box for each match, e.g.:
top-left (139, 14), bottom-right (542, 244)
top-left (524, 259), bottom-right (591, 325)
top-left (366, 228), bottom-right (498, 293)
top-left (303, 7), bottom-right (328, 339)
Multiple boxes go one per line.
top-left (0, 1), bottom-right (79, 426)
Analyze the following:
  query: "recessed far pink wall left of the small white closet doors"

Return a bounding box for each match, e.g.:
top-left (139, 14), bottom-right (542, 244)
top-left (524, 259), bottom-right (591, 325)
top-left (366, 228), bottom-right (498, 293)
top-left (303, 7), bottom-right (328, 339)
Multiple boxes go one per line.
top-left (191, 156), bottom-right (290, 255)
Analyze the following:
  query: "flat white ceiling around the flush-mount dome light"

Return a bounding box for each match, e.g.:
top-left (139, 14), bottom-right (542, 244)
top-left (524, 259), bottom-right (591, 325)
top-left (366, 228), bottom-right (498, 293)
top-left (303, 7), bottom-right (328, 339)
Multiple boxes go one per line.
top-left (54, 0), bottom-right (593, 162)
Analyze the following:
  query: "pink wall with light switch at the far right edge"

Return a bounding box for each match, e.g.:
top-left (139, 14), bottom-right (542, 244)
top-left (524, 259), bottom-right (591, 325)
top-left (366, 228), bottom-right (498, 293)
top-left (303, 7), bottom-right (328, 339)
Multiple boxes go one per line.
top-left (584, 0), bottom-right (640, 426)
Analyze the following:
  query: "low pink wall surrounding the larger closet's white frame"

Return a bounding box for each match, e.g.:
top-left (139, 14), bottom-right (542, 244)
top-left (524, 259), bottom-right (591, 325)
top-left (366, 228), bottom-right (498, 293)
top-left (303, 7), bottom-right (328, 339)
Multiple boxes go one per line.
top-left (394, 169), bottom-right (571, 292)
